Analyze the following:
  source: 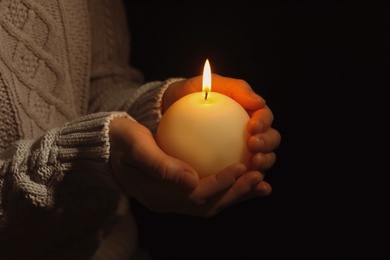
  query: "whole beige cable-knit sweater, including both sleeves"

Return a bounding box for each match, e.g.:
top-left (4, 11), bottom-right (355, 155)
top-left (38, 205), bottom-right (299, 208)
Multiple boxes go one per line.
top-left (0, 0), bottom-right (174, 259)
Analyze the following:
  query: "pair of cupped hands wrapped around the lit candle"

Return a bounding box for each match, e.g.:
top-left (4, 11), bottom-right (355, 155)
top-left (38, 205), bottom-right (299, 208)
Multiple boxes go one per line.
top-left (110, 60), bottom-right (280, 216)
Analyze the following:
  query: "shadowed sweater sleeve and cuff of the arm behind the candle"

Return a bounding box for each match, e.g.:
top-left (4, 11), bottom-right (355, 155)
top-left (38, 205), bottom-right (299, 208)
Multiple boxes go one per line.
top-left (88, 0), bottom-right (187, 132)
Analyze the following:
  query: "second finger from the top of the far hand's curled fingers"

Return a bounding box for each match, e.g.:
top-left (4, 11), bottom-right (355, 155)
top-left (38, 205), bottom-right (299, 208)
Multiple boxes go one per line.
top-left (248, 106), bottom-right (274, 135)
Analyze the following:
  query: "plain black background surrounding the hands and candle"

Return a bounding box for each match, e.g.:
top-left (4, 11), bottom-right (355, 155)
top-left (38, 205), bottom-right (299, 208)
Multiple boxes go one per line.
top-left (124, 1), bottom-right (390, 260)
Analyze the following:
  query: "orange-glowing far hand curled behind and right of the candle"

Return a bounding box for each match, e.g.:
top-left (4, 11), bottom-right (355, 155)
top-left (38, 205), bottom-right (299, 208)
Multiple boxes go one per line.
top-left (162, 74), bottom-right (281, 176)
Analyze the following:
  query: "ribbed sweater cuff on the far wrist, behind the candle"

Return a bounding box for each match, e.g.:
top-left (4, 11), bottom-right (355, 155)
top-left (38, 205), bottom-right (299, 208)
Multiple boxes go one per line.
top-left (128, 78), bottom-right (185, 134)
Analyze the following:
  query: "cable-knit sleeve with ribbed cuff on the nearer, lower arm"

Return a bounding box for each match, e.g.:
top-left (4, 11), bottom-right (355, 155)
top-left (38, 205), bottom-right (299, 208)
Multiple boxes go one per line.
top-left (0, 112), bottom-right (129, 227)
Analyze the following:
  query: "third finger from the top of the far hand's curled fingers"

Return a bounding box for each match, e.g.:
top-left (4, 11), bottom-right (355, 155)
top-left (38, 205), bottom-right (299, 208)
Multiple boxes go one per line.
top-left (247, 128), bottom-right (281, 153)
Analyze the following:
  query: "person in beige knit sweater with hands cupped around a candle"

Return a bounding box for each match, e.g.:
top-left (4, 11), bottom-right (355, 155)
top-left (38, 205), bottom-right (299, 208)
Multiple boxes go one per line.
top-left (0, 0), bottom-right (281, 259)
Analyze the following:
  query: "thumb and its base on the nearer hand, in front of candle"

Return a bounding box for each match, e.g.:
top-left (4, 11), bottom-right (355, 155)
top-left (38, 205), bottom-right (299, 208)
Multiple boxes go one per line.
top-left (110, 118), bottom-right (199, 188)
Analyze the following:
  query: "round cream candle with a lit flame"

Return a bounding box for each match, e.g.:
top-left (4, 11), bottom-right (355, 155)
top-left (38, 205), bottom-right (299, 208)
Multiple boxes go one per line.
top-left (156, 60), bottom-right (249, 178)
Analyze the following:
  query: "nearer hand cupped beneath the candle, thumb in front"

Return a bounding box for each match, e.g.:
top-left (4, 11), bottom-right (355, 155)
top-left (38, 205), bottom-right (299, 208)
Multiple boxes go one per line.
top-left (110, 118), bottom-right (271, 217)
